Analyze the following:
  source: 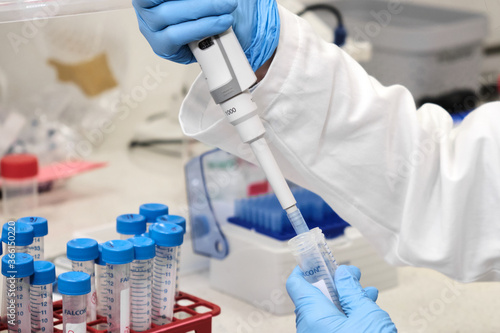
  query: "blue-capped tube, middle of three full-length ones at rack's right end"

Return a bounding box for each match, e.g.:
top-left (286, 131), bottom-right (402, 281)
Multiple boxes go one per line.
top-left (128, 237), bottom-right (156, 332)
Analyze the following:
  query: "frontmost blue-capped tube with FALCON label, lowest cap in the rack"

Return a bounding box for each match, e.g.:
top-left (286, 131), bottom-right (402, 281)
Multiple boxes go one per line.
top-left (57, 272), bottom-right (91, 333)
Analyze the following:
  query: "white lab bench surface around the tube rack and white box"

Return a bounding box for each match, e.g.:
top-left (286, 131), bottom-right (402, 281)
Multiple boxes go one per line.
top-left (26, 140), bottom-right (500, 333)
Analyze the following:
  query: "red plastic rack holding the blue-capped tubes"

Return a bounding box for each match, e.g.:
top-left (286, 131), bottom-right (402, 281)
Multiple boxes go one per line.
top-left (0, 292), bottom-right (220, 333)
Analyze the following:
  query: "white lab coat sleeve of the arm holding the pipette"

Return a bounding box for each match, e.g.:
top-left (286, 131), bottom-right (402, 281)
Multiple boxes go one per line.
top-left (179, 4), bottom-right (500, 282)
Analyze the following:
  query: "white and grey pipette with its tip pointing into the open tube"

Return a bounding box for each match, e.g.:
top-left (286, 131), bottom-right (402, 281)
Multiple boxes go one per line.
top-left (189, 28), bottom-right (309, 234)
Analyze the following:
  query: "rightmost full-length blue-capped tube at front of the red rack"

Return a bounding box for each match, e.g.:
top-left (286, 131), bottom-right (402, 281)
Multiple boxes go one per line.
top-left (149, 223), bottom-right (184, 325)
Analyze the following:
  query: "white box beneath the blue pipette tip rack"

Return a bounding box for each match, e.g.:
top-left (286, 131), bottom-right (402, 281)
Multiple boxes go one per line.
top-left (210, 223), bottom-right (397, 315)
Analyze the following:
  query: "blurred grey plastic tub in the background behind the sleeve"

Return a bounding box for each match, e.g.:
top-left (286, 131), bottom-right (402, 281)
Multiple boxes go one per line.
top-left (318, 0), bottom-right (488, 101)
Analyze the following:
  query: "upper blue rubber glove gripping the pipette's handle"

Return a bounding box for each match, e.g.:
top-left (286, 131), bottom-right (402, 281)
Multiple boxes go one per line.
top-left (132, 0), bottom-right (280, 71)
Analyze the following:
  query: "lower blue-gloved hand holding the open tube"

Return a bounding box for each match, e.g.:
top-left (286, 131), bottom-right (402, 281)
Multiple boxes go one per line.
top-left (286, 266), bottom-right (397, 333)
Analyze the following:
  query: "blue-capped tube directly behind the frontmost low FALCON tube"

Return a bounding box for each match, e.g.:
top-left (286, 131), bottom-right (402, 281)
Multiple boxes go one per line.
top-left (66, 238), bottom-right (99, 321)
